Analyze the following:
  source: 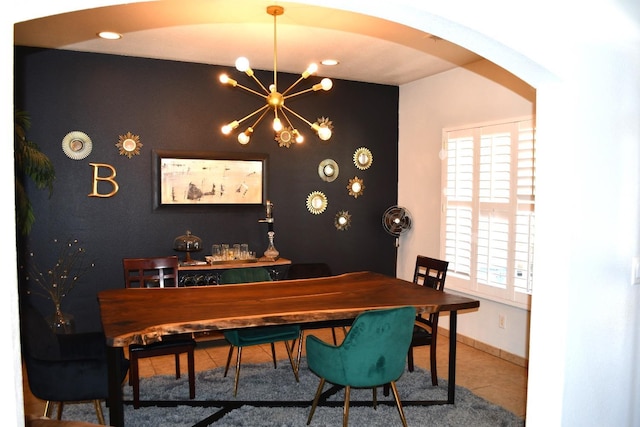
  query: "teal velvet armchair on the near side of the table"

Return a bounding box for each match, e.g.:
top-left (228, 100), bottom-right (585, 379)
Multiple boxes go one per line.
top-left (307, 307), bottom-right (416, 427)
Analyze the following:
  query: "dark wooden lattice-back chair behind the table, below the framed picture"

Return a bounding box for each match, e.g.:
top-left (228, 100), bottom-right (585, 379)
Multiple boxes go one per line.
top-left (122, 256), bottom-right (196, 408)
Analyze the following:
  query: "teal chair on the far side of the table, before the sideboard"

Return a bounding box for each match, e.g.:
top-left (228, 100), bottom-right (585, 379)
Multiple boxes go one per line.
top-left (218, 267), bottom-right (301, 396)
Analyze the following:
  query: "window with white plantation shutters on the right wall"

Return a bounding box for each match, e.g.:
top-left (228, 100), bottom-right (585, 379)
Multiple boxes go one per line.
top-left (440, 117), bottom-right (535, 309)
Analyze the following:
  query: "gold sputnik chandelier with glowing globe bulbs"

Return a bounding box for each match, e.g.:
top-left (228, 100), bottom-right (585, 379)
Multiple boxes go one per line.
top-left (220, 6), bottom-right (333, 147)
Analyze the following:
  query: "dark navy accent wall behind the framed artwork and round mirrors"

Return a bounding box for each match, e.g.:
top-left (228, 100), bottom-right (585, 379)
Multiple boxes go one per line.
top-left (15, 47), bottom-right (398, 330)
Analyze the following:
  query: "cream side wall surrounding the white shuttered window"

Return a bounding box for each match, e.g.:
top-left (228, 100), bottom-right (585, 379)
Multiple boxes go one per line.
top-left (398, 60), bottom-right (535, 358)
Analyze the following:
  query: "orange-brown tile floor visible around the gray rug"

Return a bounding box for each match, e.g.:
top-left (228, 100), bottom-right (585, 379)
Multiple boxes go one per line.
top-left (24, 329), bottom-right (527, 417)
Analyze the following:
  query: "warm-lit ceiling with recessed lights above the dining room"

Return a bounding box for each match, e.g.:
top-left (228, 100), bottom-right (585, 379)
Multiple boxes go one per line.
top-left (14, 0), bottom-right (482, 86)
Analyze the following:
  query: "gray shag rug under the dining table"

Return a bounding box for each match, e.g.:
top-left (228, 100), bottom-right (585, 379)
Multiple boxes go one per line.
top-left (62, 360), bottom-right (525, 427)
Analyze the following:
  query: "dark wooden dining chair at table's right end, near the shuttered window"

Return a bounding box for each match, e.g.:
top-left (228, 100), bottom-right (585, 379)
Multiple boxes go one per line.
top-left (407, 255), bottom-right (449, 386)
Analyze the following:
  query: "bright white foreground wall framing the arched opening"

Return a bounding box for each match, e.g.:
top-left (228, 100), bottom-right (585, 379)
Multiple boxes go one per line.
top-left (5, 0), bottom-right (640, 427)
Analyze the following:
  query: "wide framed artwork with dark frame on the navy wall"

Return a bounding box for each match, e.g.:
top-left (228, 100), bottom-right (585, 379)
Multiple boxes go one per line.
top-left (153, 150), bottom-right (268, 208)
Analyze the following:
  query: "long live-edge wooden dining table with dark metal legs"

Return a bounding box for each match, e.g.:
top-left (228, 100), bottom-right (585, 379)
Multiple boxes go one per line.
top-left (98, 272), bottom-right (480, 426)
